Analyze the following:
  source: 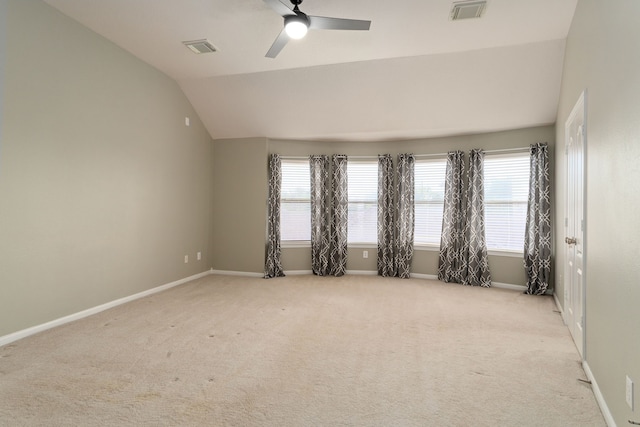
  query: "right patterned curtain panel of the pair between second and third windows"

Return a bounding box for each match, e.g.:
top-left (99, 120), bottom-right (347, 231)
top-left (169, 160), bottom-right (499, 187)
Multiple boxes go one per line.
top-left (394, 154), bottom-right (416, 279)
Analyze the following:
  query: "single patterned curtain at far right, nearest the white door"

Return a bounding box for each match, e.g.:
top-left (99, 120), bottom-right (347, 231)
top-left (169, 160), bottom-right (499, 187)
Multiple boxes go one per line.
top-left (524, 143), bottom-right (551, 295)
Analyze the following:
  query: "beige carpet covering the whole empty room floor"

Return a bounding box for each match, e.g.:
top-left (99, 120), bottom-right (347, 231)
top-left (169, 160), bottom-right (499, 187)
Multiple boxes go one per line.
top-left (0, 276), bottom-right (606, 427)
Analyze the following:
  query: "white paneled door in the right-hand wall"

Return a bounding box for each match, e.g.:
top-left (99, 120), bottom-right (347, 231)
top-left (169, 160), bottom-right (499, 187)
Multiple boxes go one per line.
top-left (564, 92), bottom-right (586, 359)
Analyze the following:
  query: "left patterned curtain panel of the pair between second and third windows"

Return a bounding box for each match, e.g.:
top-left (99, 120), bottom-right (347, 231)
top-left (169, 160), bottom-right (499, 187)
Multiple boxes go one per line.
top-left (378, 154), bottom-right (396, 277)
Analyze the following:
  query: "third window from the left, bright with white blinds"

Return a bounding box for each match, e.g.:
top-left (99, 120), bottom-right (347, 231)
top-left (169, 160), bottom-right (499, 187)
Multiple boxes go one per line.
top-left (414, 159), bottom-right (447, 246)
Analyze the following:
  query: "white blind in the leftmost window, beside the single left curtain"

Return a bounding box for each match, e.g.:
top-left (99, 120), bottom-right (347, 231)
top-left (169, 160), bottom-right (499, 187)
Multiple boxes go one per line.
top-left (280, 159), bottom-right (311, 241)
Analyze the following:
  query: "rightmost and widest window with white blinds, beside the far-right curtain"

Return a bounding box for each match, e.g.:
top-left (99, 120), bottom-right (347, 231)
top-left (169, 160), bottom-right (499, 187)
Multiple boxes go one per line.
top-left (484, 153), bottom-right (529, 252)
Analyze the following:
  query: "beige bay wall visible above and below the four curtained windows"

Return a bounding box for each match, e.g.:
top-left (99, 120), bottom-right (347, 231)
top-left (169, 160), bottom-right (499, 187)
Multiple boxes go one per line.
top-left (269, 126), bottom-right (555, 286)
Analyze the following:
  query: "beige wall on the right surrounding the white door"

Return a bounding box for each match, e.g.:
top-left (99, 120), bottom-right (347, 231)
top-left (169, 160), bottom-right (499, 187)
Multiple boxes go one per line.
top-left (556, 0), bottom-right (640, 426)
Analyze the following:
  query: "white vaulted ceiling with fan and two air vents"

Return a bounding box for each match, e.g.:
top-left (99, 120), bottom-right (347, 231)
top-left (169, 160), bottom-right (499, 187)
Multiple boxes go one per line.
top-left (45, 0), bottom-right (577, 140)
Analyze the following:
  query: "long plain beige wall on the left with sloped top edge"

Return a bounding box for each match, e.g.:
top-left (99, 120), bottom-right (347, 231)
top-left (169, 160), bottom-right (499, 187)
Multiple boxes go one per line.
top-left (0, 0), bottom-right (211, 336)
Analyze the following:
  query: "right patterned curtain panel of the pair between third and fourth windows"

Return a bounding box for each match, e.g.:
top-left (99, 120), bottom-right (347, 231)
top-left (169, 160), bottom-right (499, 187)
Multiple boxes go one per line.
top-left (464, 149), bottom-right (491, 288)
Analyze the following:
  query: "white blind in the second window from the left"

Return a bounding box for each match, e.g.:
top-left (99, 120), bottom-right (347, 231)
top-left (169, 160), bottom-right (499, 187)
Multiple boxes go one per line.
top-left (347, 159), bottom-right (378, 244)
